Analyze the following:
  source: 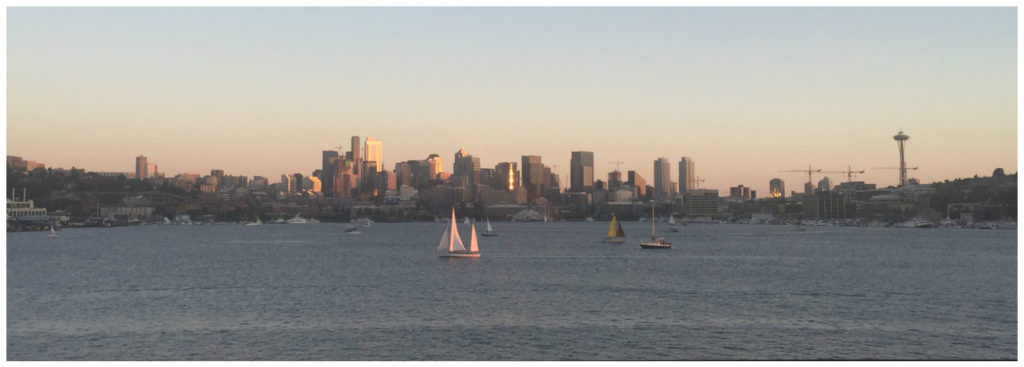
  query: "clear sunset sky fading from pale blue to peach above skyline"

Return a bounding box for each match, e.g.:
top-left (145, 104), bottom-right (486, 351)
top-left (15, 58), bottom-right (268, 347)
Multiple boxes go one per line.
top-left (6, 7), bottom-right (1018, 197)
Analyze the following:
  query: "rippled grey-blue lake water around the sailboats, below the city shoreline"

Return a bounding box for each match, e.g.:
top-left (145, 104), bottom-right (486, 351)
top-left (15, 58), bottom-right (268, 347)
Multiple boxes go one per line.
top-left (7, 222), bottom-right (1017, 361)
